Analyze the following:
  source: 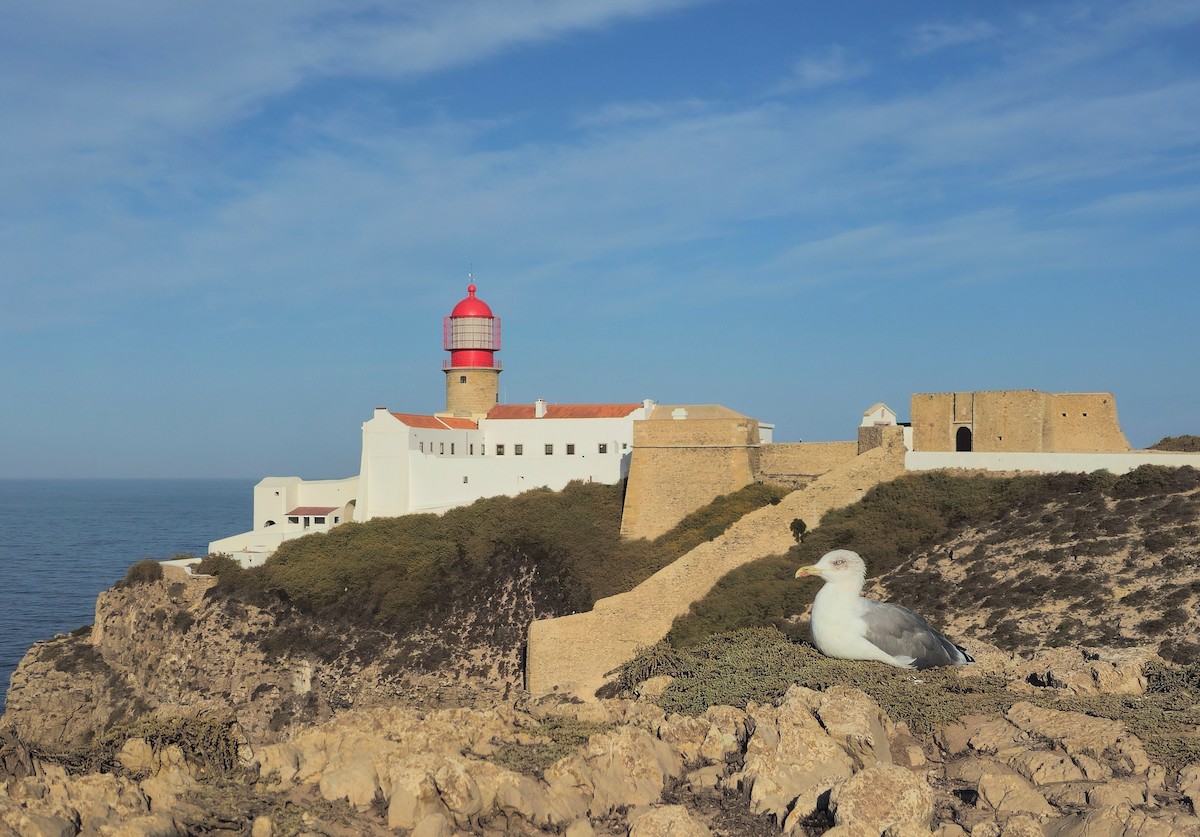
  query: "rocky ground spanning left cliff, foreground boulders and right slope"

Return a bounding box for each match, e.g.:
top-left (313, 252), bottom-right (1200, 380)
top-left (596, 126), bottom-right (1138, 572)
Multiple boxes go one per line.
top-left (0, 465), bottom-right (1200, 837)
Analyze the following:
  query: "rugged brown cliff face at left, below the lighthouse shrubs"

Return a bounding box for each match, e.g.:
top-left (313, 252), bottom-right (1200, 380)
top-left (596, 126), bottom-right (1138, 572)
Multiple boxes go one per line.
top-left (5, 567), bottom-right (544, 753)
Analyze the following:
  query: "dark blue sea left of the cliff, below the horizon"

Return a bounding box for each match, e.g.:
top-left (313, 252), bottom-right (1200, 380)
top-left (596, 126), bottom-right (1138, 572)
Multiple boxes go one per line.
top-left (0, 480), bottom-right (254, 713)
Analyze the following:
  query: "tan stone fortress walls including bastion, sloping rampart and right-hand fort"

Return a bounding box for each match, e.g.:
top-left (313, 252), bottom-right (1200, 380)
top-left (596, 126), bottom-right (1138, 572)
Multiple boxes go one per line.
top-left (526, 390), bottom-right (1180, 700)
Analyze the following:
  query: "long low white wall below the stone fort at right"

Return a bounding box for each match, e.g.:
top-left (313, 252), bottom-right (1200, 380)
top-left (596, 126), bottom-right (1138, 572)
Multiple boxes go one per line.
top-left (905, 451), bottom-right (1200, 474)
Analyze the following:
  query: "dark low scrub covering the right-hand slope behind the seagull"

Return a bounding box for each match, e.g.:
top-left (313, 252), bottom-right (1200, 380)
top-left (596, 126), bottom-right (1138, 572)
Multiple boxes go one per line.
top-left (668, 465), bottom-right (1200, 647)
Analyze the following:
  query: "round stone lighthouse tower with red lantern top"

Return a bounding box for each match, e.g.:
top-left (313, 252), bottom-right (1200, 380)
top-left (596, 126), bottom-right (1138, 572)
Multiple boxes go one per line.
top-left (442, 283), bottom-right (500, 417)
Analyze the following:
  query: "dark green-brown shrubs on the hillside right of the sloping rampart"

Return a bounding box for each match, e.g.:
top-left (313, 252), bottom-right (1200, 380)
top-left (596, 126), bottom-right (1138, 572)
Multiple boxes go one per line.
top-left (668, 465), bottom-right (1200, 648)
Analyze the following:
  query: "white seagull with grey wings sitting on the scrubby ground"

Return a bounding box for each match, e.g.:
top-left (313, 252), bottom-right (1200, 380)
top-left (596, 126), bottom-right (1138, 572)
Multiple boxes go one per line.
top-left (796, 549), bottom-right (974, 669)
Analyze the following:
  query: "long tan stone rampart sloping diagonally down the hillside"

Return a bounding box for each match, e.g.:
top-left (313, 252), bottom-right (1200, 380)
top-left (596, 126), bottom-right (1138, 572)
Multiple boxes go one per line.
top-left (526, 428), bottom-right (905, 700)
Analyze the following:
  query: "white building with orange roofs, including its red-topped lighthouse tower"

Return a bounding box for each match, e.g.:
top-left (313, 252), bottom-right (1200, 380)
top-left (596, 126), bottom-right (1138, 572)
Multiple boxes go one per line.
top-left (209, 285), bottom-right (654, 566)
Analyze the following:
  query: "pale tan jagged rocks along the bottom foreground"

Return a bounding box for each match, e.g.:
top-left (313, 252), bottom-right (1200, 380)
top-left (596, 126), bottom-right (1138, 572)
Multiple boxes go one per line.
top-left (0, 637), bottom-right (1200, 837)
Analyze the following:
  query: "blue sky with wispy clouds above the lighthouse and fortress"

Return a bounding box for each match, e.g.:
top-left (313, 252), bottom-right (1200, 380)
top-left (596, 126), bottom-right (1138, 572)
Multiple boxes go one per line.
top-left (0, 0), bottom-right (1200, 478)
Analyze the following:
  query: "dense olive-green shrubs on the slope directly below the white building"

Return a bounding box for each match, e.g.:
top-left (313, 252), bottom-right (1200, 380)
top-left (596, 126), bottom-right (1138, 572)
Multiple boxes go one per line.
top-left (199, 482), bottom-right (786, 628)
